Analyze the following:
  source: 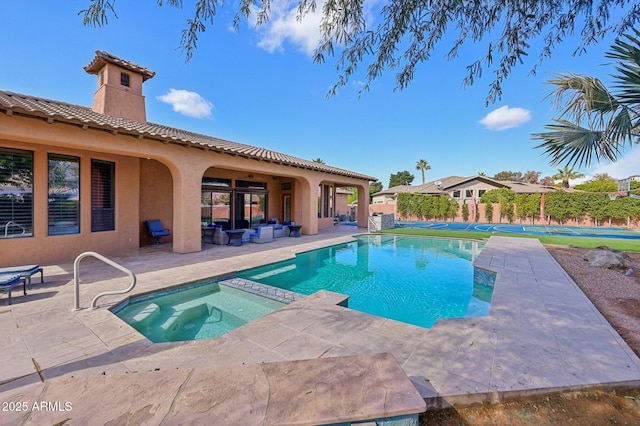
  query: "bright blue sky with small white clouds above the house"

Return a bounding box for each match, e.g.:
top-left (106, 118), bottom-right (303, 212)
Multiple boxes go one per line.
top-left (0, 0), bottom-right (640, 187)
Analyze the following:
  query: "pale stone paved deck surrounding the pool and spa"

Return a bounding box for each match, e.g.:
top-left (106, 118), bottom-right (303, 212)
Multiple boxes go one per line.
top-left (0, 227), bottom-right (640, 424)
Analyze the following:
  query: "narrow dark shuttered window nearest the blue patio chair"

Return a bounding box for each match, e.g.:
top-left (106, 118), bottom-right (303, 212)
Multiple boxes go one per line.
top-left (91, 160), bottom-right (116, 232)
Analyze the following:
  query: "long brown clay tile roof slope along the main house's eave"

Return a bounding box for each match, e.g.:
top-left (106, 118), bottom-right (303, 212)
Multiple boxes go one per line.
top-left (0, 91), bottom-right (377, 181)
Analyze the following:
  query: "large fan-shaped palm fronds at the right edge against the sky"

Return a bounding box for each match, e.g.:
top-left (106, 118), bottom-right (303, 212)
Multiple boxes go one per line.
top-left (532, 29), bottom-right (640, 167)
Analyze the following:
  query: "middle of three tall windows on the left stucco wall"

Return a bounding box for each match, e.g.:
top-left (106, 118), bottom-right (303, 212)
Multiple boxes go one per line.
top-left (49, 154), bottom-right (80, 235)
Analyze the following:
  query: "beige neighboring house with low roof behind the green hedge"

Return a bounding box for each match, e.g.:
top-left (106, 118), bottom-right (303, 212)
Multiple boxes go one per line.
top-left (371, 176), bottom-right (557, 206)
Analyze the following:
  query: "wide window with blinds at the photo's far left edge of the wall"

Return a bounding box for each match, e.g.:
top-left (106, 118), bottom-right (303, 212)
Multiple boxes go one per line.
top-left (0, 148), bottom-right (33, 238)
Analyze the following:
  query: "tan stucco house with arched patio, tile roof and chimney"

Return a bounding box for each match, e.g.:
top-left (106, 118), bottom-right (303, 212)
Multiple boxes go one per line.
top-left (0, 51), bottom-right (376, 266)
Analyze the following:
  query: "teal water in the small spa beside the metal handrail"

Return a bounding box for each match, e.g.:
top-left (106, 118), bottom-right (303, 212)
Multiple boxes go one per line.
top-left (113, 282), bottom-right (285, 343)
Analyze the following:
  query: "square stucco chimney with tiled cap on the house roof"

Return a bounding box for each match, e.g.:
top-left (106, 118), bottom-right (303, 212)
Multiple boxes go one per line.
top-left (84, 50), bottom-right (156, 123)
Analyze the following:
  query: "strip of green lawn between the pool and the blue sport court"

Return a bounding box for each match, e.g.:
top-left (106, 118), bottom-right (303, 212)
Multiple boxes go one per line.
top-left (381, 228), bottom-right (640, 252)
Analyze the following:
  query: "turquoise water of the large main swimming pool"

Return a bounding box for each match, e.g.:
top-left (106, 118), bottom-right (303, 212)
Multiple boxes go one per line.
top-left (237, 235), bottom-right (495, 328)
